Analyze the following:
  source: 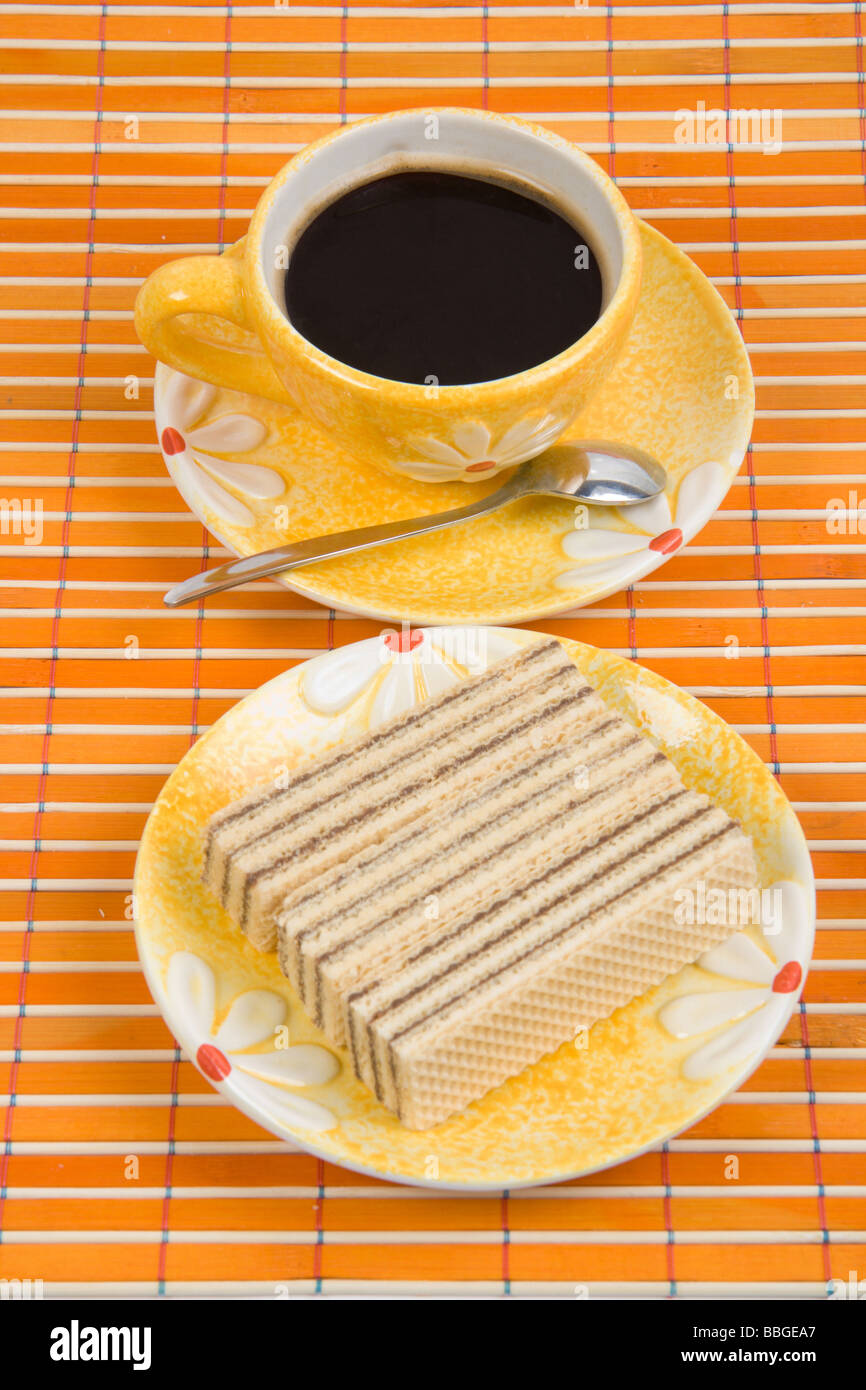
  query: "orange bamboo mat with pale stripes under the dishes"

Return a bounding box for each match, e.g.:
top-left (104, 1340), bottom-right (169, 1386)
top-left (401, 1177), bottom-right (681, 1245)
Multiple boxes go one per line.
top-left (0, 0), bottom-right (866, 1298)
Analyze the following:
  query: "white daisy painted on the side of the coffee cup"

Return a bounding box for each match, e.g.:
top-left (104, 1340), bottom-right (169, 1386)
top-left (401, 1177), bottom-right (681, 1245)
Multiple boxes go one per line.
top-left (402, 414), bottom-right (569, 482)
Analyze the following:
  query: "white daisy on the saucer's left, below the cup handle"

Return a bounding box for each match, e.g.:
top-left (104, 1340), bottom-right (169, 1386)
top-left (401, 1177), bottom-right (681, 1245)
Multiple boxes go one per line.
top-left (160, 371), bottom-right (285, 527)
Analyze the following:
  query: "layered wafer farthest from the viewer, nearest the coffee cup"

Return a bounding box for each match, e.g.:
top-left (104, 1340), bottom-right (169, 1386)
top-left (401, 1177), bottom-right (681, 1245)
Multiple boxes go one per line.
top-left (203, 639), bottom-right (603, 951)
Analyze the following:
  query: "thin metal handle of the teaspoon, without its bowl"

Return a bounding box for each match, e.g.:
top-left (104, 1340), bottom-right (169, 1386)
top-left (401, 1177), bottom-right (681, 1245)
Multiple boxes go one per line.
top-left (163, 478), bottom-right (523, 607)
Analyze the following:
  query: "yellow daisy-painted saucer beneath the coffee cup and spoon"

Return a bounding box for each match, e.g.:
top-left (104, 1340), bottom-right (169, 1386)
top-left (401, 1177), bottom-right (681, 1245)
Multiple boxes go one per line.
top-left (154, 224), bottom-right (753, 624)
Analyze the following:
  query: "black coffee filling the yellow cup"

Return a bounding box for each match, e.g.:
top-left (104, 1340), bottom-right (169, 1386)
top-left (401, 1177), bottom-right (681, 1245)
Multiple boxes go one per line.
top-left (285, 171), bottom-right (602, 386)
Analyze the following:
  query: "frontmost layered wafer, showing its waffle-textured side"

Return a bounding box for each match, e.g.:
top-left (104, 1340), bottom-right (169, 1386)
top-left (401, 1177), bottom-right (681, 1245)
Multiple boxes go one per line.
top-left (345, 787), bottom-right (756, 1129)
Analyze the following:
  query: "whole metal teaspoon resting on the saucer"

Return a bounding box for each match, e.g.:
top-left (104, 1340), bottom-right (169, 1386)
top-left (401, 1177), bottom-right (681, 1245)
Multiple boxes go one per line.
top-left (163, 439), bottom-right (666, 607)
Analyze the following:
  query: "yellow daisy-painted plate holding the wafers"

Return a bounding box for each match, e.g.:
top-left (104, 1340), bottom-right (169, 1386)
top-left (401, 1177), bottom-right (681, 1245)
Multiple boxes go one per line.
top-left (135, 627), bottom-right (815, 1190)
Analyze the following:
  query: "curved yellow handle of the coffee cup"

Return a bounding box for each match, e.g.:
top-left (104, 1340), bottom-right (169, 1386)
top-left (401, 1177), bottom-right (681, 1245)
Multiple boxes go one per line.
top-left (135, 247), bottom-right (295, 404)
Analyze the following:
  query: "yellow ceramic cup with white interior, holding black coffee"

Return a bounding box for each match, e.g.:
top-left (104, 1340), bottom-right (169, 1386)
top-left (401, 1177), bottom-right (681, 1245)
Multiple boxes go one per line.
top-left (135, 108), bottom-right (641, 482)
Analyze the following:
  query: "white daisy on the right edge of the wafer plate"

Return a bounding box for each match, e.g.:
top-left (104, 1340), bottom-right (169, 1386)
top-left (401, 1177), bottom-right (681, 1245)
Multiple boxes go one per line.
top-left (659, 881), bottom-right (809, 1081)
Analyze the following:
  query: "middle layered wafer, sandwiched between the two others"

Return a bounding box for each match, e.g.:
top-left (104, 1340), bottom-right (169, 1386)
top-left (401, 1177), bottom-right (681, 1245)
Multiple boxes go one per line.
top-left (277, 702), bottom-right (680, 1044)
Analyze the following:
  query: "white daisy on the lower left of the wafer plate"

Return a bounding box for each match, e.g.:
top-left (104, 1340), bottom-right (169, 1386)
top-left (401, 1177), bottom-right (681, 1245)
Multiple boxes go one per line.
top-left (165, 951), bottom-right (339, 1130)
